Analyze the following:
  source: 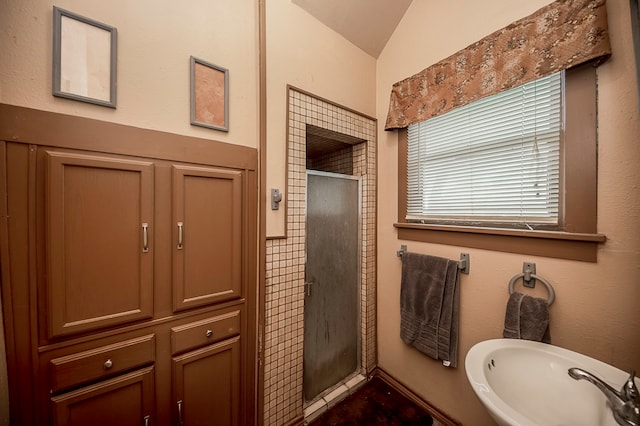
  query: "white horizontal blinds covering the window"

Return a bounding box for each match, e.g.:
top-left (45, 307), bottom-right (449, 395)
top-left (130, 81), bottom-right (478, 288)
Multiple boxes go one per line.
top-left (406, 73), bottom-right (564, 225)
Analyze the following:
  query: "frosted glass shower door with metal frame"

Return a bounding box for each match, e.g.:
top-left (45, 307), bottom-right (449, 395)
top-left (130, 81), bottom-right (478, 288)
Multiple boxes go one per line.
top-left (304, 171), bottom-right (360, 401)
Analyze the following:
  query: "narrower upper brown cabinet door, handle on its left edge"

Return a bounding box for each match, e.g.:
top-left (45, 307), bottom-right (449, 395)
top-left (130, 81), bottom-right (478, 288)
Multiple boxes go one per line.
top-left (173, 165), bottom-right (243, 311)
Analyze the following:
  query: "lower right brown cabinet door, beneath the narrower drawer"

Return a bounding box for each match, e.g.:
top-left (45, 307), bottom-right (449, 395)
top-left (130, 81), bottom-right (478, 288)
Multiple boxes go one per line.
top-left (173, 337), bottom-right (240, 426)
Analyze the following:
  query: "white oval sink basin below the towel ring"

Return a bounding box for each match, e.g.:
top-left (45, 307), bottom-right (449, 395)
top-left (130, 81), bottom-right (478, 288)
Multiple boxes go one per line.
top-left (465, 339), bottom-right (638, 426)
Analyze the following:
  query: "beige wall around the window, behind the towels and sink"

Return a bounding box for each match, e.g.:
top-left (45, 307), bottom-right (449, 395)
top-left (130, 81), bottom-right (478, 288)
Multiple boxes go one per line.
top-left (377, 0), bottom-right (640, 425)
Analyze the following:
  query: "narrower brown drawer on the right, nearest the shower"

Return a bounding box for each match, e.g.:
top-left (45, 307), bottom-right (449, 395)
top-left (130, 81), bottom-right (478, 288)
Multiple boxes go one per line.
top-left (171, 311), bottom-right (240, 354)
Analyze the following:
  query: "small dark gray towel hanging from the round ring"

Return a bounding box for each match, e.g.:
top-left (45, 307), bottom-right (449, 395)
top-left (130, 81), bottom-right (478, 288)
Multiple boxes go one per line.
top-left (502, 291), bottom-right (551, 343)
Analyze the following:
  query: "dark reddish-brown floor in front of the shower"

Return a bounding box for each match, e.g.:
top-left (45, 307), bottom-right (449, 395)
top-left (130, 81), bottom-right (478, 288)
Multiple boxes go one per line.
top-left (309, 377), bottom-right (433, 426)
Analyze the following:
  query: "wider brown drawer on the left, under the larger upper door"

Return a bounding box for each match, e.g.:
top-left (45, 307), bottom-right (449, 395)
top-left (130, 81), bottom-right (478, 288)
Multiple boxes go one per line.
top-left (49, 334), bottom-right (155, 393)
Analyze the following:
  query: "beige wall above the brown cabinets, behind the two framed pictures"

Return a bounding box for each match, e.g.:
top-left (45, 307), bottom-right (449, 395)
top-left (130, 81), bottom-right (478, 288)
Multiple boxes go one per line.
top-left (0, 0), bottom-right (259, 147)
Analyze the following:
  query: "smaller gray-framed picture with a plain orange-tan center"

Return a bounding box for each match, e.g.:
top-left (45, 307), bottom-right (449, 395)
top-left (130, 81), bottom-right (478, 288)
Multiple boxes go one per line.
top-left (191, 56), bottom-right (229, 132)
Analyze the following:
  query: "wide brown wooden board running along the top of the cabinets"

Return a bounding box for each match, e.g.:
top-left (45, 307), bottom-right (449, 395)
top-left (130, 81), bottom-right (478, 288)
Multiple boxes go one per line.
top-left (0, 104), bottom-right (258, 170)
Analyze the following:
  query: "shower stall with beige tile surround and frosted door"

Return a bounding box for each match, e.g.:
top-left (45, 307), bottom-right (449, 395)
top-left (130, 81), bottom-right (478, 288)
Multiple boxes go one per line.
top-left (264, 86), bottom-right (377, 426)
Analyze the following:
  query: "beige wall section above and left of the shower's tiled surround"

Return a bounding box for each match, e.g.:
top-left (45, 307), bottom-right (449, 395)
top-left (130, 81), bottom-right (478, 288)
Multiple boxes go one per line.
top-left (265, 1), bottom-right (376, 237)
